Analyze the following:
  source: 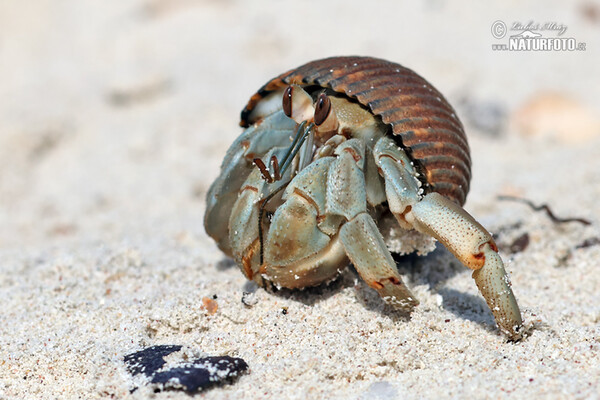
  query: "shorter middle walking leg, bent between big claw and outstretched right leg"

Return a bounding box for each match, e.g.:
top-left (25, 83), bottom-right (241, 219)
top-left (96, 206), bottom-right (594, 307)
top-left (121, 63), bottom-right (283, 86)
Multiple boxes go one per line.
top-left (327, 139), bottom-right (418, 310)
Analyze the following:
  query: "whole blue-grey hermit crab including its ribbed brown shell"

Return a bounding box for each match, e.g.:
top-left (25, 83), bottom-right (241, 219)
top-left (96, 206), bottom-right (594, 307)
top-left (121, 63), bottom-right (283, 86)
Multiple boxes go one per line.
top-left (204, 57), bottom-right (522, 340)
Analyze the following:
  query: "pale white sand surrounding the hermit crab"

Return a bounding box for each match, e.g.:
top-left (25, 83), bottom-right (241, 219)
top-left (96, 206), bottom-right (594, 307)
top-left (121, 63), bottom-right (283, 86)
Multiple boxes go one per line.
top-left (0, 0), bottom-right (600, 399)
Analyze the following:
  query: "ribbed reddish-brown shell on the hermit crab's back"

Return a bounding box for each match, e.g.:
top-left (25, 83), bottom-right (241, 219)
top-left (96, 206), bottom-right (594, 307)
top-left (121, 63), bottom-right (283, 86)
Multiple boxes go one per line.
top-left (240, 57), bottom-right (471, 205)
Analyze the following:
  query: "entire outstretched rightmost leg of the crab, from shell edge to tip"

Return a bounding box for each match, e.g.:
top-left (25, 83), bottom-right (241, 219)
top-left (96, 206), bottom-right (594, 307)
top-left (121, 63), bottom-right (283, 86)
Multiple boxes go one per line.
top-left (373, 137), bottom-right (522, 339)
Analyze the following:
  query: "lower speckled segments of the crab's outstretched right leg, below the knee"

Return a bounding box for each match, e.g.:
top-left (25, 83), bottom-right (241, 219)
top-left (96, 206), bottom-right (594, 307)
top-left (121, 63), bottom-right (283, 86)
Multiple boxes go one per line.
top-left (406, 193), bottom-right (523, 340)
